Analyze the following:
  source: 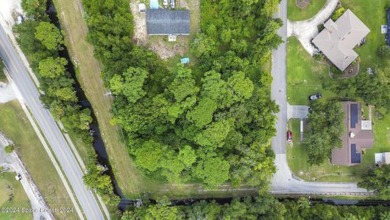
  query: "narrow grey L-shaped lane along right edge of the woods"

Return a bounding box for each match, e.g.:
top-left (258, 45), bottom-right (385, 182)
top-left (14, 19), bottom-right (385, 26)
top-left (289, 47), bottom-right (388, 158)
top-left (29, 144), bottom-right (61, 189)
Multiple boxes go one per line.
top-left (271, 0), bottom-right (367, 195)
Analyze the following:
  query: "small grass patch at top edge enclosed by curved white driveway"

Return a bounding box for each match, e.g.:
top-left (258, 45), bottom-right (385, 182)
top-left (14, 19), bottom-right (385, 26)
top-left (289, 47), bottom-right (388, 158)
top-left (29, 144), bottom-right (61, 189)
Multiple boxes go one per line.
top-left (287, 0), bottom-right (326, 21)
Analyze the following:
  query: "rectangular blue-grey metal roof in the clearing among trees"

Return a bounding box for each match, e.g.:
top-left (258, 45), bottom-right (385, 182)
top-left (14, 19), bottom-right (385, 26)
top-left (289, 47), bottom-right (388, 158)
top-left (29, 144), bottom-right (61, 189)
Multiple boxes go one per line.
top-left (146, 9), bottom-right (190, 35)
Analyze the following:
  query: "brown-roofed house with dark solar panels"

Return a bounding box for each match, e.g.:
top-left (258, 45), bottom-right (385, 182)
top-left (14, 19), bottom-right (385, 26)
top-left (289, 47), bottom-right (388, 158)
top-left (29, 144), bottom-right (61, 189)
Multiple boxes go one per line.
top-left (332, 102), bottom-right (374, 166)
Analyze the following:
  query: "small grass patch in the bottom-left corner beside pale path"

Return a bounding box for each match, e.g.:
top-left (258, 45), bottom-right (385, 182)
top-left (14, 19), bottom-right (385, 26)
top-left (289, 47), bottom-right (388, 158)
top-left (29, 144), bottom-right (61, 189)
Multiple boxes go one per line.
top-left (0, 172), bottom-right (33, 220)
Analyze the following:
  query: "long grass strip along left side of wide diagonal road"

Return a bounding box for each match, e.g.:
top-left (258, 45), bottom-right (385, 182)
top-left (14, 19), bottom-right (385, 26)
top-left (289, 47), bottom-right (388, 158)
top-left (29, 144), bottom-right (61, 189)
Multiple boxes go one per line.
top-left (0, 101), bottom-right (77, 219)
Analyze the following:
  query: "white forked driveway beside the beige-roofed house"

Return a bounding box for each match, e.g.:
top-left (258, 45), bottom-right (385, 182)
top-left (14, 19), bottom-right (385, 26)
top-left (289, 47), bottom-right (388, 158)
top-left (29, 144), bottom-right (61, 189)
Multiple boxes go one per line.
top-left (287, 0), bottom-right (338, 55)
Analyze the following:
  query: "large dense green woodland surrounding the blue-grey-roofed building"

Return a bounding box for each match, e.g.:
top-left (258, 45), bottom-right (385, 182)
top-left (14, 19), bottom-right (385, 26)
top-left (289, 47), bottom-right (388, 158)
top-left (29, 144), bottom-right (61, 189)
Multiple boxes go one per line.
top-left (83, 0), bottom-right (281, 188)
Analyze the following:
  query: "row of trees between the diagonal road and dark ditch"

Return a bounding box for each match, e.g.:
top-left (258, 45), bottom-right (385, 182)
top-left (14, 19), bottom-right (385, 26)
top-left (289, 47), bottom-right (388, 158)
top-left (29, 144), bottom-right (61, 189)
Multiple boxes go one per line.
top-left (14, 3), bottom-right (92, 143)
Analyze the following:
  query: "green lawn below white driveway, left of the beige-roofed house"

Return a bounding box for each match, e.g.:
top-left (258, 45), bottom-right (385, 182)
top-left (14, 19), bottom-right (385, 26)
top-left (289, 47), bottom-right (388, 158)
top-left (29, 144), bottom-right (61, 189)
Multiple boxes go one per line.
top-left (287, 37), bottom-right (334, 105)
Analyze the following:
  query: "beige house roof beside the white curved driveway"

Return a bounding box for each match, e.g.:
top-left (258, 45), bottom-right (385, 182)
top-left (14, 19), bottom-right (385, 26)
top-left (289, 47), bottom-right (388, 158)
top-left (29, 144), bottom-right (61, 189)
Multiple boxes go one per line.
top-left (313, 9), bottom-right (370, 70)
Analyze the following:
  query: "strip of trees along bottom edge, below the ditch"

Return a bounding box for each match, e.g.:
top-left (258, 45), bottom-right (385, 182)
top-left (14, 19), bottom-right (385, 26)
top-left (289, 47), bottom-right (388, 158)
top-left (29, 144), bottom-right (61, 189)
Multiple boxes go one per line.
top-left (121, 195), bottom-right (390, 220)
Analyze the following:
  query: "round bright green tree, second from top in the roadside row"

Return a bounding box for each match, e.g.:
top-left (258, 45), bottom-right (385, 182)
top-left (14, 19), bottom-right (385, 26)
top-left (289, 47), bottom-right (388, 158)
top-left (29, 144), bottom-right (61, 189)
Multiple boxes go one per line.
top-left (35, 21), bottom-right (64, 50)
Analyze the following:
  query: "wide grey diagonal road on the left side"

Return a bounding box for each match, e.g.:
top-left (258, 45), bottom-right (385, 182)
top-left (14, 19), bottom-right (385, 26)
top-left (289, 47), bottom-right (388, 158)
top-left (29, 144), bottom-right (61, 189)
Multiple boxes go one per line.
top-left (0, 25), bottom-right (104, 220)
